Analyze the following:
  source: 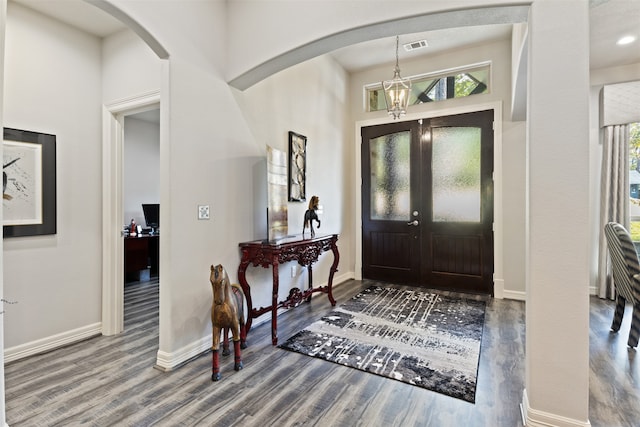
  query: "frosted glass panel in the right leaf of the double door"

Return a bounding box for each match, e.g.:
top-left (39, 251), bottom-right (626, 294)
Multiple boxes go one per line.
top-left (431, 127), bottom-right (481, 222)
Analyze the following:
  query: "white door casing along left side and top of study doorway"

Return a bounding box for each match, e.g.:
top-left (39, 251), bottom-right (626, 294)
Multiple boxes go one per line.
top-left (102, 90), bottom-right (160, 335)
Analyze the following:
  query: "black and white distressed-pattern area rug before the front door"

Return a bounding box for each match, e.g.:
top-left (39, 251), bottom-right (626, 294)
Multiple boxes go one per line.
top-left (280, 286), bottom-right (486, 402)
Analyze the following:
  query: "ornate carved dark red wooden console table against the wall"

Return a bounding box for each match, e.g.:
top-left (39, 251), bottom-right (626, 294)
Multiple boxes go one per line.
top-left (238, 234), bottom-right (340, 345)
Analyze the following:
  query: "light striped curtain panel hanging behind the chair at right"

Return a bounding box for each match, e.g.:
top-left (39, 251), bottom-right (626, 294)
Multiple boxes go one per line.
top-left (597, 125), bottom-right (630, 299)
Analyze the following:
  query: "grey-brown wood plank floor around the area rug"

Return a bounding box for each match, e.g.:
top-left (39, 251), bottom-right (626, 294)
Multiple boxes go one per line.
top-left (5, 281), bottom-right (640, 427)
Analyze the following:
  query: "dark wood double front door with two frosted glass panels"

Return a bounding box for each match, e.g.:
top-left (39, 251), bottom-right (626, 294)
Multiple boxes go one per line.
top-left (362, 110), bottom-right (493, 294)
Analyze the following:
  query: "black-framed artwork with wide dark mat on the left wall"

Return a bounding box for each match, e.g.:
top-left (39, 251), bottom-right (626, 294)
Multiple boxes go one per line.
top-left (2, 128), bottom-right (57, 237)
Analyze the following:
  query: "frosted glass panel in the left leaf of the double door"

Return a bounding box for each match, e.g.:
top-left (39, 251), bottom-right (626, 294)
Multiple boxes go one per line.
top-left (369, 131), bottom-right (411, 221)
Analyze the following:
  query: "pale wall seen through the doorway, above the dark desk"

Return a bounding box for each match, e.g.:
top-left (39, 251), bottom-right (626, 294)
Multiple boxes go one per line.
top-left (123, 117), bottom-right (160, 227)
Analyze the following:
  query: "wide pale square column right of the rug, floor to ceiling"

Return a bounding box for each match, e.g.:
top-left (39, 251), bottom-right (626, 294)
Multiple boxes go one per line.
top-left (523, 0), bottom-right (590, 427)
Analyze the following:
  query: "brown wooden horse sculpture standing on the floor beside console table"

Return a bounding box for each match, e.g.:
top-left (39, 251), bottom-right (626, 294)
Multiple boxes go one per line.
top-left (209, 264), bottom-right (247, 381)
